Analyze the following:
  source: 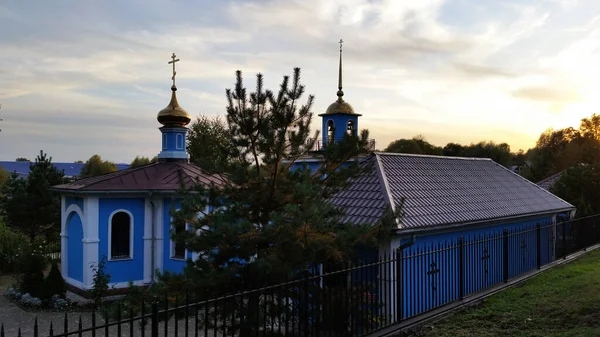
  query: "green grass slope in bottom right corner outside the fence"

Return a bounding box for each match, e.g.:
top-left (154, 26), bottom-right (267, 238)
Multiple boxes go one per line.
top-left (408, 250), bottom-right (600, 337)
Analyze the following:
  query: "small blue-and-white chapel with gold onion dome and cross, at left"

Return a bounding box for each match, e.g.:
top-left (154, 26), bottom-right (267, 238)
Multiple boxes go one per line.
top-left (52, 54), bottom-right (222, 296)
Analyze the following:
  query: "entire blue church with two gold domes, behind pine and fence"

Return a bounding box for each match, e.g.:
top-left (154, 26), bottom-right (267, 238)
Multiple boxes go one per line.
top-left (53, 41), bottom-right (575, 305)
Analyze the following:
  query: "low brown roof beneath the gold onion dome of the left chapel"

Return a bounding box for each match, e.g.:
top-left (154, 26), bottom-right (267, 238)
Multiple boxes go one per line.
top-left (52, 161), bottom-right (223, 193)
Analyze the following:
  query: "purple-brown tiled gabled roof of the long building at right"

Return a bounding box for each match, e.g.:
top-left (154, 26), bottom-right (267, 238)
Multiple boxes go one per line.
top-left (332, 153), bottom-right (575, 229)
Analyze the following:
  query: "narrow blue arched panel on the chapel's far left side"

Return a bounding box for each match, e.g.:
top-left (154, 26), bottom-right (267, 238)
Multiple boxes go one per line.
top-left (67, 212), bottom-right (83, 282)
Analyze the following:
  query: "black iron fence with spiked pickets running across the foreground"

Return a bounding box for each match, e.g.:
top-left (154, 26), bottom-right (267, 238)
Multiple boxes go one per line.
top-left (0, 215), bottom-right (600, 337)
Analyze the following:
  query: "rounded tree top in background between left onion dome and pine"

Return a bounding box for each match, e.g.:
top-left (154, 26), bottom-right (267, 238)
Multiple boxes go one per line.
top-left (187, 115), bottom-right (234, 172)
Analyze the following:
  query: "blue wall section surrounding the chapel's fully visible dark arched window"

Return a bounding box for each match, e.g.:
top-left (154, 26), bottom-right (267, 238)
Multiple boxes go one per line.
top-left (98, 198), bottom-right (145, 282)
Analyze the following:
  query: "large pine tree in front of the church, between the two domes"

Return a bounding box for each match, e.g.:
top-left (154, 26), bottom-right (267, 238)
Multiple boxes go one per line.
top-left (173, 68), bottom-right (391, 333)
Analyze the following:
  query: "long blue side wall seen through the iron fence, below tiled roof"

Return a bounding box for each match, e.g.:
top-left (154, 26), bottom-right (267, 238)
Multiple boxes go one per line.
top-left (400, 216), bottom-right (556, 318)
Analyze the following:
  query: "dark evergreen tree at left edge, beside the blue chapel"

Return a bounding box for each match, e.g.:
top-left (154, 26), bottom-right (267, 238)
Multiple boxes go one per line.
top-left (0, 151), bottom-right (65, 241)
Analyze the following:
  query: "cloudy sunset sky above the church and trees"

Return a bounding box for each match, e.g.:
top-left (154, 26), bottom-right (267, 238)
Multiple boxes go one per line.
top-left (0, 0), bottom-right (600, 163)
